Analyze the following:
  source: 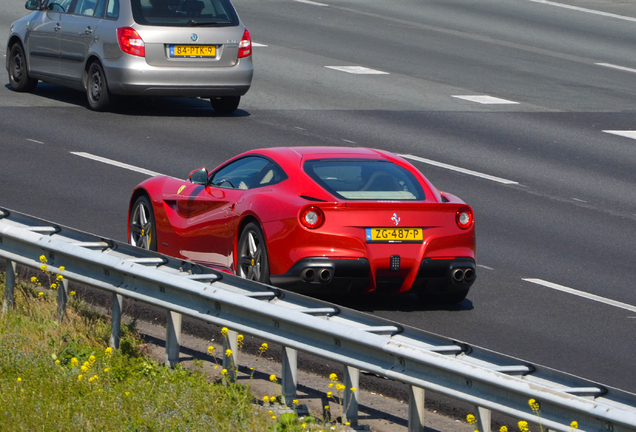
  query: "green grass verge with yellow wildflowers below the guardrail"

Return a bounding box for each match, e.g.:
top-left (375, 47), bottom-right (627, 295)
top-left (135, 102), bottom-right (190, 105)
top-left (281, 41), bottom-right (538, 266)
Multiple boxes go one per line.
top-left (0, 274), bottom-right (272, 432)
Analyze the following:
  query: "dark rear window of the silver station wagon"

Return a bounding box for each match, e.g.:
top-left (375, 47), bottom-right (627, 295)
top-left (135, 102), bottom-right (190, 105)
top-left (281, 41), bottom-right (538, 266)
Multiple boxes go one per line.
top-left (131, 0), bottom-right (239, 27)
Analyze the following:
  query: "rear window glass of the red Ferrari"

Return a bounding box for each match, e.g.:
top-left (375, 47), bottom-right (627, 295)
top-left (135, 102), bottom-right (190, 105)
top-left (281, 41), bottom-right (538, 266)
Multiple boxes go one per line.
top-left (304, 159), bottom-right (426, 201)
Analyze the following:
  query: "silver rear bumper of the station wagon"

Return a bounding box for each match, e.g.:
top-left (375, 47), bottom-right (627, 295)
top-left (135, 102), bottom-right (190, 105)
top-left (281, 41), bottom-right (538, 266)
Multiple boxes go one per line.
top-left (104, 58), bottom-right (254, 97)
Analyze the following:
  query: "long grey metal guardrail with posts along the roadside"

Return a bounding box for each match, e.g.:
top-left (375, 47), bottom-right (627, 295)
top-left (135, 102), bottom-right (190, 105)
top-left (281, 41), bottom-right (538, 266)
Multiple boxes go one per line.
top-left (0, 208), bottom-right (636, 432)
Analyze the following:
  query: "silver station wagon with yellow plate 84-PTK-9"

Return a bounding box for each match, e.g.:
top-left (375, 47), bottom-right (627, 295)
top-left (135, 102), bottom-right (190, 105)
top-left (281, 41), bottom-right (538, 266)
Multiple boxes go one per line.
top-left (6, 0), bottom-right (254, 114)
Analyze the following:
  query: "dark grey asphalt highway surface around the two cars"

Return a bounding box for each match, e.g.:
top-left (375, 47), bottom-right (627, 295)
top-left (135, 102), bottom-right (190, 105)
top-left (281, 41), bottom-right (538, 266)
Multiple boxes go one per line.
top-left (0, 0), bottom-right (636, 392)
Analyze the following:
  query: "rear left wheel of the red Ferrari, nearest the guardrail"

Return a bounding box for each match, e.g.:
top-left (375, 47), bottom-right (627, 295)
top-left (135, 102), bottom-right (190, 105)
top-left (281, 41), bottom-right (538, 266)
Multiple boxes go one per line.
top-left (237, 222), bottom-right (269, 283)
